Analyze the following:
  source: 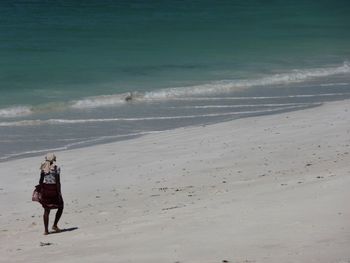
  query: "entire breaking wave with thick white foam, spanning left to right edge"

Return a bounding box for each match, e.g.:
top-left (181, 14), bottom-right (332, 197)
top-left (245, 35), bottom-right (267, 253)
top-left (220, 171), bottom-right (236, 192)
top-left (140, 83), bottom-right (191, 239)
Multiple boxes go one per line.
top-left (0, 61), bottom-right (350, 118)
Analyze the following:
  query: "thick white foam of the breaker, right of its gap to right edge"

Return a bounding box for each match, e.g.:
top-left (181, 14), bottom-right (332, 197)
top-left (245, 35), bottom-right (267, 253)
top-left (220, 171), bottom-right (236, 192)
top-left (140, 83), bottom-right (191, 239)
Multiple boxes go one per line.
top-left (70, 62), bottom-right (350, 109)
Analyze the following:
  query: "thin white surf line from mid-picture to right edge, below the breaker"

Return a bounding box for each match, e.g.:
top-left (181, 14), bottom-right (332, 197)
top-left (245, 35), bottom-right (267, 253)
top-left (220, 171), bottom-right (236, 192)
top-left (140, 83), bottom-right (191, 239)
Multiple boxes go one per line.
top-left (167, 92), bottom-right (350, 101)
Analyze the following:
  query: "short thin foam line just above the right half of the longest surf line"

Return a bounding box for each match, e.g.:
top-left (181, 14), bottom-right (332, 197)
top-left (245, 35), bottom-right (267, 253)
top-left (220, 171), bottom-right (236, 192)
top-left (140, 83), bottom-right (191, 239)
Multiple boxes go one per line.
top-left (168, 103), bottom-right (320, 109)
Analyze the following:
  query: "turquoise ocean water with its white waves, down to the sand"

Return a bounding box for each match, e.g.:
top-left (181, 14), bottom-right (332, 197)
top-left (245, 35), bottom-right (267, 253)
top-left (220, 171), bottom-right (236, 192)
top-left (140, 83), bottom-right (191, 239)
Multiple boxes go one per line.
top-left (0, 0), bottom-right (350, 160)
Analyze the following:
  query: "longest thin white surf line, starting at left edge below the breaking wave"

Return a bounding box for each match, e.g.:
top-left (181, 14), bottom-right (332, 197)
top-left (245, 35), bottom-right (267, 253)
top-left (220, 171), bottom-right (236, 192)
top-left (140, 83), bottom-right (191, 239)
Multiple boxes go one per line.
top-left (0, 104), bottom-right (321, 127)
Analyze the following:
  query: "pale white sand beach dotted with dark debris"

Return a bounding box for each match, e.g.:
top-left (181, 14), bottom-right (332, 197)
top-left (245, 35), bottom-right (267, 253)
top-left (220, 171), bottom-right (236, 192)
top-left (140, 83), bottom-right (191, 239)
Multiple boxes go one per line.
top-left (0, 100), bottom-right (350, 263)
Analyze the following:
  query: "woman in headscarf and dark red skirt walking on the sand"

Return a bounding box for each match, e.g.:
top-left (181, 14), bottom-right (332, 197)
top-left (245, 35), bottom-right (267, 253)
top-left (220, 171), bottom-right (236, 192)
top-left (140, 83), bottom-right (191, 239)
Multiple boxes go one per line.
top-left (39, 153), bottom-right (63, 235)
